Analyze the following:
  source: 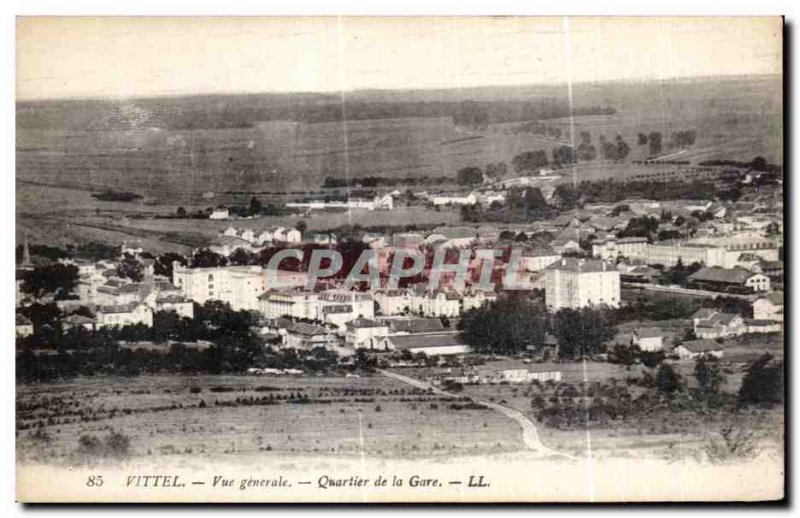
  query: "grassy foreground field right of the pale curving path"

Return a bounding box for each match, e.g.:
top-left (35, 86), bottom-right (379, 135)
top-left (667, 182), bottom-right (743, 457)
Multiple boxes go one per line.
top-left (401, 354), bottom-right (784, 460)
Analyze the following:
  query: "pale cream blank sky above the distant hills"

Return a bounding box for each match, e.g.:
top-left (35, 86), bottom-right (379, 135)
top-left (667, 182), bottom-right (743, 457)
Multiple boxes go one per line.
top-left (17, 17), bottom-right (782, 99)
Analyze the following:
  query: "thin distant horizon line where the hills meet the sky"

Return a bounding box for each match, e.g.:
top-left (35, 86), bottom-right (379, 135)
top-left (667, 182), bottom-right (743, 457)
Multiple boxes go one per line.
top-left (14, 71), bottom-right (783, 104)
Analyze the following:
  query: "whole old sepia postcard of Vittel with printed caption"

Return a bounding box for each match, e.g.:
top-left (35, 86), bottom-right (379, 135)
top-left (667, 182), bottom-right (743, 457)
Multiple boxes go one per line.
top-left (15, 16), bottom-right (785, 503)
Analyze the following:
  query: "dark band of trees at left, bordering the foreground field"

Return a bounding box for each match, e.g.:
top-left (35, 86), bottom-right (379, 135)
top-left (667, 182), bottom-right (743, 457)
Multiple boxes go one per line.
top-left (17, 301), bottom-right (338, 381)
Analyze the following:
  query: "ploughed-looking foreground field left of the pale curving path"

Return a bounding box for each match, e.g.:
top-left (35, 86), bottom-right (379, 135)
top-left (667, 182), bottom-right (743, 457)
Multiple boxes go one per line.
top-left (17, 376), bottom-right (523, 463)
